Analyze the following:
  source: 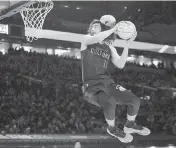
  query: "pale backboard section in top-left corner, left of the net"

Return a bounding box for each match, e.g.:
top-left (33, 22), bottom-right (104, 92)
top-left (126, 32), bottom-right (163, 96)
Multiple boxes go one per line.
top-left (0, 0), bottom-right (35, 20)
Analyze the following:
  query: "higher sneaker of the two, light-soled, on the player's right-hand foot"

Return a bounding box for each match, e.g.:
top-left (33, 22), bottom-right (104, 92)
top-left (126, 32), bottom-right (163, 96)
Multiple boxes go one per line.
top-left (124, 121), bottom-right (151, 136)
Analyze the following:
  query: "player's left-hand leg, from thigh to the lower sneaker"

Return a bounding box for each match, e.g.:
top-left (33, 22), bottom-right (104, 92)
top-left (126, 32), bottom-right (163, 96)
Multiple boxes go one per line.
top-left (83, 91), bottom-right (133, 143)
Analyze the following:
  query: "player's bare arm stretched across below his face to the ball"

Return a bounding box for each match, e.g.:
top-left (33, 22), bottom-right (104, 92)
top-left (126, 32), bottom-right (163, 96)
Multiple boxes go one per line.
top-left (81, 24), bottom-right (118, 50)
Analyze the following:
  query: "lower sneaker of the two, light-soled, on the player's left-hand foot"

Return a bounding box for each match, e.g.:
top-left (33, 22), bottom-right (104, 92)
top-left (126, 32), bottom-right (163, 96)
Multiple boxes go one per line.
top-left (107, 126), bottom-right (133, 143)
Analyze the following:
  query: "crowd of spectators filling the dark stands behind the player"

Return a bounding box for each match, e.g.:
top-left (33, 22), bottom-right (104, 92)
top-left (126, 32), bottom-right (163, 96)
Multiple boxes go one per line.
top-left (0, 49), bottom-right (176, 134)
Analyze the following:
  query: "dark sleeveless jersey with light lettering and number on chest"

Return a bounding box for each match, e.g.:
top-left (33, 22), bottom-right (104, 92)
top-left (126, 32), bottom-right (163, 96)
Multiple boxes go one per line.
top-left (81, 43), bottom-right (111, 82)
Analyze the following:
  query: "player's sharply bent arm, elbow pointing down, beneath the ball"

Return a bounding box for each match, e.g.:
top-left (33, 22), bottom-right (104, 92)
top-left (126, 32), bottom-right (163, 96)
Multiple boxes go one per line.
top-left (110, 32), bottom-right (137, 69)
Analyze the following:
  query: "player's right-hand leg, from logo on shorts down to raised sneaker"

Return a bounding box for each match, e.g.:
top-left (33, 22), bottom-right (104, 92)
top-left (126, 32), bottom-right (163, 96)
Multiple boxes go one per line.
top-left (109, 84), bottom-right (150, 135)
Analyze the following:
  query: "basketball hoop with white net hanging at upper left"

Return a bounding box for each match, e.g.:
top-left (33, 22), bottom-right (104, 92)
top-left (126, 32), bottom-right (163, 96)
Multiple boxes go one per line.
top-left (20, 0), bottom-right (54, 42)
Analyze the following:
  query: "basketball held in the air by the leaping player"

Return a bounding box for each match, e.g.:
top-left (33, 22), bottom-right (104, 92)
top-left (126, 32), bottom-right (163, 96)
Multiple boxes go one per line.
top-left (116, 21), bottom-right (136, 40)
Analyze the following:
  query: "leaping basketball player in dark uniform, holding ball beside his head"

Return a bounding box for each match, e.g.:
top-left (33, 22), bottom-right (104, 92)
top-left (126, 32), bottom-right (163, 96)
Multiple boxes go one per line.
top-left (81, 15), bottom-right (150, 143)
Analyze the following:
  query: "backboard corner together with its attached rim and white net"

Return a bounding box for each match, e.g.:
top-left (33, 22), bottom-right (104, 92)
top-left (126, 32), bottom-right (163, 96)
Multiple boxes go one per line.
top-left (0, 0), bottom-right (54, 42)
